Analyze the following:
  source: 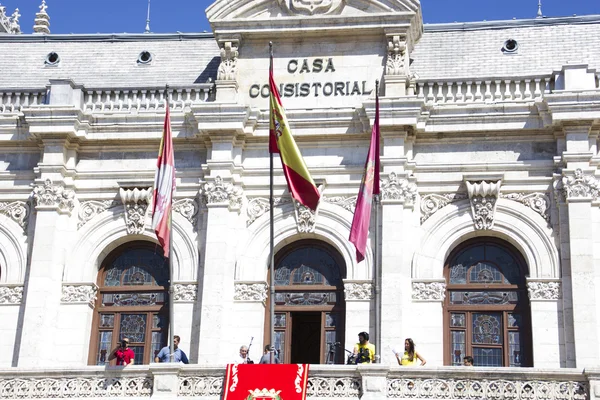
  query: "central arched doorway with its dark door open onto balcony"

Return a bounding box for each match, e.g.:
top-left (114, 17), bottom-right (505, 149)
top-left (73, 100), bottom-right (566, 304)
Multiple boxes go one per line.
top-left (265, 240), bottom-right (346, 364)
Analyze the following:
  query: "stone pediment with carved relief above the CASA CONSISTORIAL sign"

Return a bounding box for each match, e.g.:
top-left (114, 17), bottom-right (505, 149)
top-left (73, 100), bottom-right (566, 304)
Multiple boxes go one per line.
top-left (206, 0), bottom-right (420, 23)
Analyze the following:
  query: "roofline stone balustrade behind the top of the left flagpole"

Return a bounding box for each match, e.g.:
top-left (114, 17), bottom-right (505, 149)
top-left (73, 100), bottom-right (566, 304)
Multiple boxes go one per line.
top-left (83, 85), bottom-right (212, 113)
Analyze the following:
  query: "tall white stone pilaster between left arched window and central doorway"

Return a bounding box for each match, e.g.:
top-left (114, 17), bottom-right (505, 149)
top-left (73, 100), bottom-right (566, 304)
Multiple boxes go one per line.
top-left (198, 176), bottom-right (243, 364)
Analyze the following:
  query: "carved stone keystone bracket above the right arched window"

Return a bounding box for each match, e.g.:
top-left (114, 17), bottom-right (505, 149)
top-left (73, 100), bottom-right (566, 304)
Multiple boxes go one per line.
top-left (467, 180), bottom-right (502, 230)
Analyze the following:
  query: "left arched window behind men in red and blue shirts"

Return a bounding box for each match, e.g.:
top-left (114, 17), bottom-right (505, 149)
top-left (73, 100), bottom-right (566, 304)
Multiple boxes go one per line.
top-left (89, 242), bottom-right (169, 365)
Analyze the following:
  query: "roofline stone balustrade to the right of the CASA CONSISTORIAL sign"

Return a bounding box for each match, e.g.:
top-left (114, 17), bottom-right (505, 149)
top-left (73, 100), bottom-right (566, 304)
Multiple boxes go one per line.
top-left (416, 75), bottom-right (552, 105)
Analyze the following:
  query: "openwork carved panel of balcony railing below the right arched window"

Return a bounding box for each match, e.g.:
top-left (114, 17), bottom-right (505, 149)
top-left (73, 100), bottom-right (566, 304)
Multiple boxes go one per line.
top-left (387, 377), bottom-right (588, 400)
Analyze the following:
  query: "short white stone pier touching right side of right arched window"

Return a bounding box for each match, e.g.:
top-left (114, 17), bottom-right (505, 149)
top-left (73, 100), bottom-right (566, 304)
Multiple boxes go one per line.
top-left (527, 279), bottom-right (561, 368)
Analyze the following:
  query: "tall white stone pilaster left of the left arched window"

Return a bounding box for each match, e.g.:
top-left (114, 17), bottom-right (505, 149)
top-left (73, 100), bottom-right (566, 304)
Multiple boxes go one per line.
top-left (18, 178), bottom-right (75, 367)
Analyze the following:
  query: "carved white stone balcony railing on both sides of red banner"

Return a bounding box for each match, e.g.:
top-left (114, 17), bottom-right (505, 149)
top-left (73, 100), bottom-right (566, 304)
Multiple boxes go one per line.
top-left (0, 364), bottom-right (600, 400)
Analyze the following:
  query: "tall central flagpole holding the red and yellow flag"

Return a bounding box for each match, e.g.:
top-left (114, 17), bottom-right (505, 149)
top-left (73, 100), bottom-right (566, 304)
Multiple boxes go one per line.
top-left (269, 42), bottom-right (276, 364)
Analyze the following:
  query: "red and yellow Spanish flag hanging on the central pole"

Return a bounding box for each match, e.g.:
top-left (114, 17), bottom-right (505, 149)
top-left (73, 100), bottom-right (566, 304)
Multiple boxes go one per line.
top-left (269, 56), bottom-right (321, 211)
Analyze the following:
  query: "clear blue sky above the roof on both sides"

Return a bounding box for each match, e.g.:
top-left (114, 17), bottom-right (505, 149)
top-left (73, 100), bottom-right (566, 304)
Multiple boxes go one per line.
top-left (5, 0), bottom-right (600, 33)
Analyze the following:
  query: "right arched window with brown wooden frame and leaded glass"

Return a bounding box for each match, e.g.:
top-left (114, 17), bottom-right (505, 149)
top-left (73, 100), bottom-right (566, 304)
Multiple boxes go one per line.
top-left (444, 238), bottom-right (533, 367)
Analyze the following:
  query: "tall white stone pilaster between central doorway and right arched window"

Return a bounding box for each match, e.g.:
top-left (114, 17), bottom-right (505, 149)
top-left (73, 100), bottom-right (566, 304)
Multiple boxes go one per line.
top-left (379, 172), bottom-right (417, 365)
